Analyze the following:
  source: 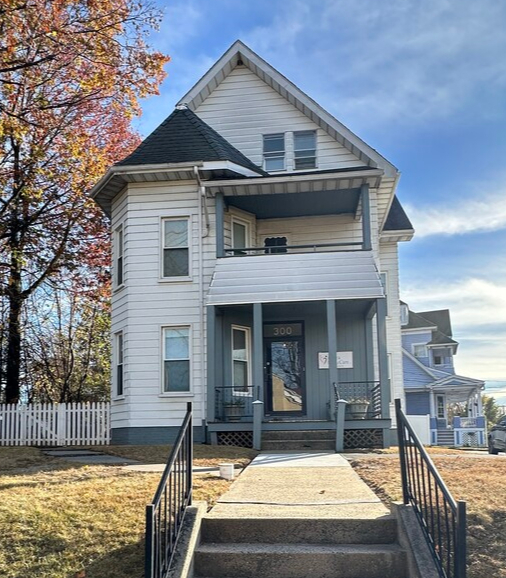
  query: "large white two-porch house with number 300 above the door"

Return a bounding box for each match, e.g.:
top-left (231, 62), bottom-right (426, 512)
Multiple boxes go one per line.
top-left (92, 41), bottom-right (413, 446)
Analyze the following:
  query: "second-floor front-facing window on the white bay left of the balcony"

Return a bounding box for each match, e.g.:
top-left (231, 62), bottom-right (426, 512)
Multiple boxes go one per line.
top-left (162, 218), bottom-right (190, 278)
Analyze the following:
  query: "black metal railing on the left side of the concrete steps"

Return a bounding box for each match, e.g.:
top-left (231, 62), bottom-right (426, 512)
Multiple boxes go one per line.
top-left (144, 403), bottom-right (193, 578)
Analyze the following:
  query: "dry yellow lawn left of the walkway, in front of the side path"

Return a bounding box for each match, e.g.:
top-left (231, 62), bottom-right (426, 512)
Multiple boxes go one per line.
top-left (0, 448), bottom-right (253, 578)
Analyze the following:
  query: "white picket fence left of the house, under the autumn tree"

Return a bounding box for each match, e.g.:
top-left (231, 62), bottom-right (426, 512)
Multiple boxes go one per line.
top-left (0, 402), bottom-right (111, 446)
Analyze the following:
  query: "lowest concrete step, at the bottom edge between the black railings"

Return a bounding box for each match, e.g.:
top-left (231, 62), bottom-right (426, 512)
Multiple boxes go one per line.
top-left (195, 544), bottom-right (407, 578)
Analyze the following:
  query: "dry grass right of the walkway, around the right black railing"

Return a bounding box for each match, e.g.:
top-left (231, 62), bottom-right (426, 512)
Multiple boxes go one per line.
top-left (353, 452), bottom-right (506, 578)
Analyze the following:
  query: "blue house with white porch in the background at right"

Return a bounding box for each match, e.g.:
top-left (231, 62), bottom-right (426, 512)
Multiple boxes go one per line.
top-left (400, 301), bottom-right (485, 446)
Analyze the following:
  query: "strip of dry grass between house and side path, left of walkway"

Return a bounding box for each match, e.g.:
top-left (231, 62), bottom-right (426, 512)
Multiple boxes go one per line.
top-left (95, 444), bottom-right (258, 466)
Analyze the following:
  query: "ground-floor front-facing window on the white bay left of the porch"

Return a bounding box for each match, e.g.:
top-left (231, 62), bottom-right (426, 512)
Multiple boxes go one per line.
top-left (163, 327), bottom-right (190, 393)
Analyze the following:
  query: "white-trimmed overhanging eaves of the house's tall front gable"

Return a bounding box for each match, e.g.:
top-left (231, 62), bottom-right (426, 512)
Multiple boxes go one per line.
top-left (180, 40), bottom-right (399, 177)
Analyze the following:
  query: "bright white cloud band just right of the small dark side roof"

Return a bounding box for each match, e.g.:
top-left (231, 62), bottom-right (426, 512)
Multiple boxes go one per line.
top-left (406, 186), bottom-right (506, 238)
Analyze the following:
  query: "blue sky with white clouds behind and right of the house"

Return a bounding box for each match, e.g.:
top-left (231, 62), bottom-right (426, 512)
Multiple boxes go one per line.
top-left (137, 0), bottom-right (506, 404)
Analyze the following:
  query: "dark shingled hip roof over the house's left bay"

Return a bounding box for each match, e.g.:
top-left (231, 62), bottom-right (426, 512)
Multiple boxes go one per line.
top-left (116, 108), bottom-right (267, 175)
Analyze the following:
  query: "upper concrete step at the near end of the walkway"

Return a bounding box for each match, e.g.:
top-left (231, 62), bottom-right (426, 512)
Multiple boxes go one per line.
top-left (201, 516), bottom-right (397, 544)
